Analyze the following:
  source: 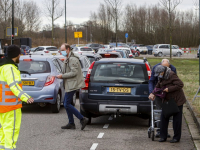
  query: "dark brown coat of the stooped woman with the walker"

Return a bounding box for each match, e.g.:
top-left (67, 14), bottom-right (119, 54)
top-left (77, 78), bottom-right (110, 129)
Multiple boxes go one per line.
top-left (153, 71), bottom-right (186, 106)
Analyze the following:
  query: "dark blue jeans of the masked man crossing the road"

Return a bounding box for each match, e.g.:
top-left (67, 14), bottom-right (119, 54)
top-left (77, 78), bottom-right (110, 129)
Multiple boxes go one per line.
top-left (64, 91), bottom-right (83, 124)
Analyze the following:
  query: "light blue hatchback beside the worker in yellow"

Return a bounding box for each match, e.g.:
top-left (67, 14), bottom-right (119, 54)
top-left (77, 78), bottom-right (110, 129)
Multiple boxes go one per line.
top-left (19, 55), bottom-right (76, 113)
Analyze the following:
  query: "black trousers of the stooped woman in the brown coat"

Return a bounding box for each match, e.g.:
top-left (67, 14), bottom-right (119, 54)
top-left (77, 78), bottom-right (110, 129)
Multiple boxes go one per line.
top-left (160, 105), bottom-right (183, 141)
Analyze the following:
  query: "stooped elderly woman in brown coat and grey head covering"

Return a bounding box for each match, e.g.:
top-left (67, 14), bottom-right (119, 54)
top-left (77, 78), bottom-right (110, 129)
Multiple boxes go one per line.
top-left (149, 65), bottom-right (186, 143)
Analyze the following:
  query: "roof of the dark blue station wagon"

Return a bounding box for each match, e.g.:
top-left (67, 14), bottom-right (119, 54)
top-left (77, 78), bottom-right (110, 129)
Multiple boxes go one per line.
top-left (98, 58), bottom-right (144, 64)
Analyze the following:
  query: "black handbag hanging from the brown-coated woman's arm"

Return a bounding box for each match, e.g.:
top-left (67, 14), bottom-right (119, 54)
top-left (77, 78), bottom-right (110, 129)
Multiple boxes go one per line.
top-left (162, 98), bottom-right (180, 118)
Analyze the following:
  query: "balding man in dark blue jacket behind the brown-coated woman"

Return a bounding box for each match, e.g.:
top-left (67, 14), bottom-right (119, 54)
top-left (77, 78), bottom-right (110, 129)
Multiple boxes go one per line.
top-left (149, 59), bottom-right (176, 138)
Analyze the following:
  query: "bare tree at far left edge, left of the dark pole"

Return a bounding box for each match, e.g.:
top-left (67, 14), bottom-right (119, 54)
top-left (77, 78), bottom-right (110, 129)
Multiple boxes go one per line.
top-left (0, 0), bottom-right (12, 38)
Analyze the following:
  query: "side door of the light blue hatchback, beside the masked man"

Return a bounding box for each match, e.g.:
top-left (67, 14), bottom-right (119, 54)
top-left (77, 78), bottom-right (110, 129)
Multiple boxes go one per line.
top-left (53, 59), bottom-right (65, 102)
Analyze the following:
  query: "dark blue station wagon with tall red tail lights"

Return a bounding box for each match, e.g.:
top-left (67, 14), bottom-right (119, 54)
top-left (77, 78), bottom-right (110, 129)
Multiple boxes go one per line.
top-left (79, 58), bottom-right (151, 123)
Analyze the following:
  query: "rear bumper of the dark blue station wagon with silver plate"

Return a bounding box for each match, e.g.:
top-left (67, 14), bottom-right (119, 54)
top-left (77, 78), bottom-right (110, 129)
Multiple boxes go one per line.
top-left (79, 93), bottom-right (151, 116)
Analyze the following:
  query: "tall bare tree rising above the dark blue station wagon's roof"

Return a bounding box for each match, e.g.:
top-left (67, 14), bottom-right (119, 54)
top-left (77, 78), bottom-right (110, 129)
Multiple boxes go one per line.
top-left (104, 0), bottom-right (122, 47)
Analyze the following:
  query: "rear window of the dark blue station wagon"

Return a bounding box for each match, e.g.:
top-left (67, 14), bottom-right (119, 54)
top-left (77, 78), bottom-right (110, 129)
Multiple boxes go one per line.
top-left (90, 63), bottom-right (148, 83)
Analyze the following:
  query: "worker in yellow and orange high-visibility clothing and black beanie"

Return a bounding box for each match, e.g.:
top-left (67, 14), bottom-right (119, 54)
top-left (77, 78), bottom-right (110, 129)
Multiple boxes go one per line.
top-left (0, 45), bottom-right (34, 150)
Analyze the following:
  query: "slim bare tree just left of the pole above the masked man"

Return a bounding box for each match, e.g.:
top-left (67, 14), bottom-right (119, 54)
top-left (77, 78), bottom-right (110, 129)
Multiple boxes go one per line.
top-left (44, 0), bottom-right (64, 45)
